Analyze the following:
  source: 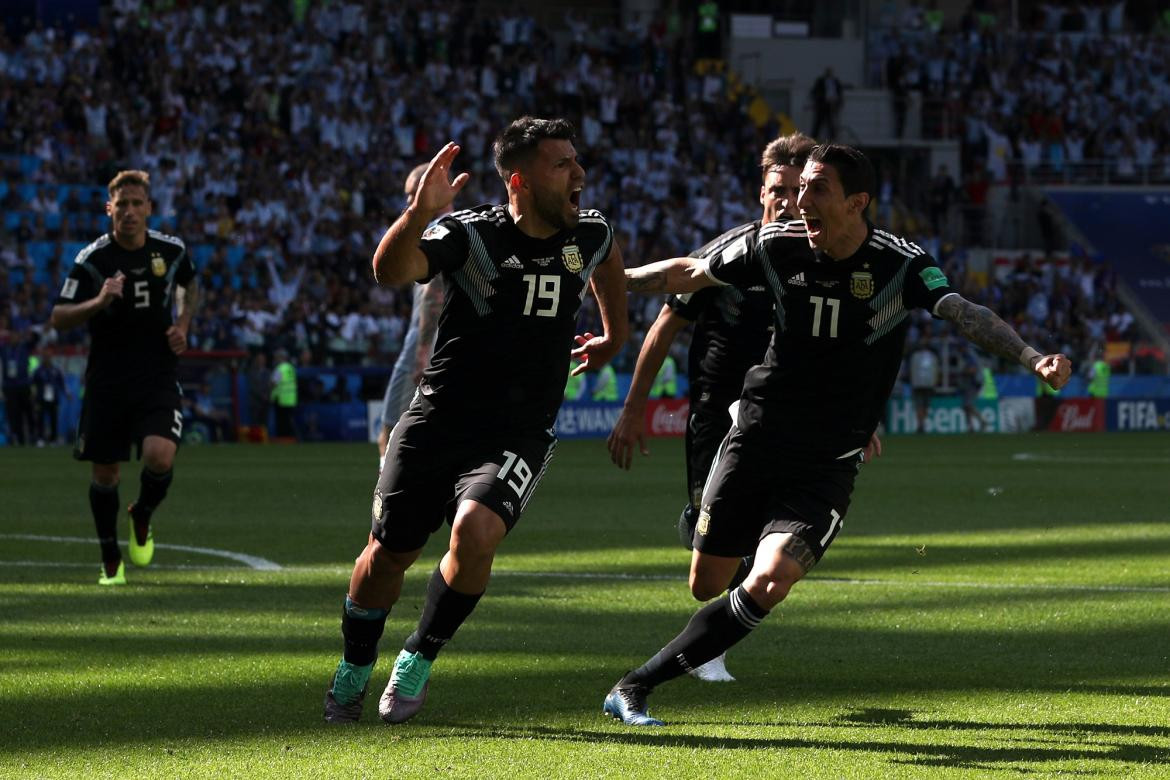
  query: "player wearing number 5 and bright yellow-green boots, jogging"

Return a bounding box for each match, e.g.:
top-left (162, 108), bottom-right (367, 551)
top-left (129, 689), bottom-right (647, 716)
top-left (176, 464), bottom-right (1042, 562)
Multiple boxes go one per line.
top-left (49, 171), bottom-right (199, 585)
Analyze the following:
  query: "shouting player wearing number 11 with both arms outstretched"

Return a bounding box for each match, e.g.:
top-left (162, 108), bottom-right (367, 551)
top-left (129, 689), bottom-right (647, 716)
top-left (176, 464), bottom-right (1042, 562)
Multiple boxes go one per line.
top-left (604, 144), bottom-right (1072, 726)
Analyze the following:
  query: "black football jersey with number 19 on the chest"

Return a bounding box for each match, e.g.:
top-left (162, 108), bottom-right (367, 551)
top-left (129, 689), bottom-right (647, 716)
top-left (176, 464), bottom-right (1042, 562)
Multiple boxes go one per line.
top-left (419, 205), bottom-right (613, 429)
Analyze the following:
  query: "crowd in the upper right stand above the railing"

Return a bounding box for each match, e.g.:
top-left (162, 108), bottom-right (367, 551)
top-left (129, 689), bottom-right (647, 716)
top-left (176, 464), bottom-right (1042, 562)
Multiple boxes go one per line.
top-left (868, 0), bottom-right (1170, 182)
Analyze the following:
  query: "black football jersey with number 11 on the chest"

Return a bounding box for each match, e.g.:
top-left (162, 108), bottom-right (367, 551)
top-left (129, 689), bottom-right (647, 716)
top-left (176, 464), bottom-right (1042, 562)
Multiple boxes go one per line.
top-left (708, 221), bottom-right (954, 457)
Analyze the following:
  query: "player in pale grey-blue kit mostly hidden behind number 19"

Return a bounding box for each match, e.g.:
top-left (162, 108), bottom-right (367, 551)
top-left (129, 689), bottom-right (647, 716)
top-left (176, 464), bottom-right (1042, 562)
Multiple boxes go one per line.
top-left (378, 163), bottom-right (452, 471)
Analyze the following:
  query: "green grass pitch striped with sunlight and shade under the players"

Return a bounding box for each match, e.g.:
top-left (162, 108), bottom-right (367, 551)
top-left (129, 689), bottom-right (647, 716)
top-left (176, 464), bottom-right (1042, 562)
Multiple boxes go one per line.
top-left (0, 434), bottom-right (1170, 779)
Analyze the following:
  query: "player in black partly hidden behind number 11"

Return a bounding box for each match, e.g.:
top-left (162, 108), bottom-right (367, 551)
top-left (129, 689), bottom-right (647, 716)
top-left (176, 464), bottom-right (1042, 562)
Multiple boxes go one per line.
top-left (608, 132), bottom-right (815, 682)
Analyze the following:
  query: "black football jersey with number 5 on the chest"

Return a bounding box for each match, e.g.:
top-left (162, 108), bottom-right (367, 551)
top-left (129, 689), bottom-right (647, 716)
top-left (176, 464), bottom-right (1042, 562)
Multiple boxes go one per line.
top-left (56, 230), bottom-right (195, 386)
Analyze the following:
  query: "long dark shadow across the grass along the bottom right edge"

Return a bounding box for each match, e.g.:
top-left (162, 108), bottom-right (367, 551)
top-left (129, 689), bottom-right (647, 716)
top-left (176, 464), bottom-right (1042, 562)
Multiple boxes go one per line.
top-left (439, 710), bottom-right (1170, 774)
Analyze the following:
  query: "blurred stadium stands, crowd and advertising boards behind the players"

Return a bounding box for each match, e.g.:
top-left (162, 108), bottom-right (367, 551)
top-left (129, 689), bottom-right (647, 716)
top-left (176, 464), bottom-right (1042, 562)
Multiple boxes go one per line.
top-left (0, 0), bottom-right (1170, 444)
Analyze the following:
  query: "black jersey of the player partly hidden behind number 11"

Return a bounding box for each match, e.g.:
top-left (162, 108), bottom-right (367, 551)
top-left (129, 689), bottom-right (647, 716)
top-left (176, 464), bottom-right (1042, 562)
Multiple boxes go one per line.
top-left (667, 221), bottom-right (776, 409)
